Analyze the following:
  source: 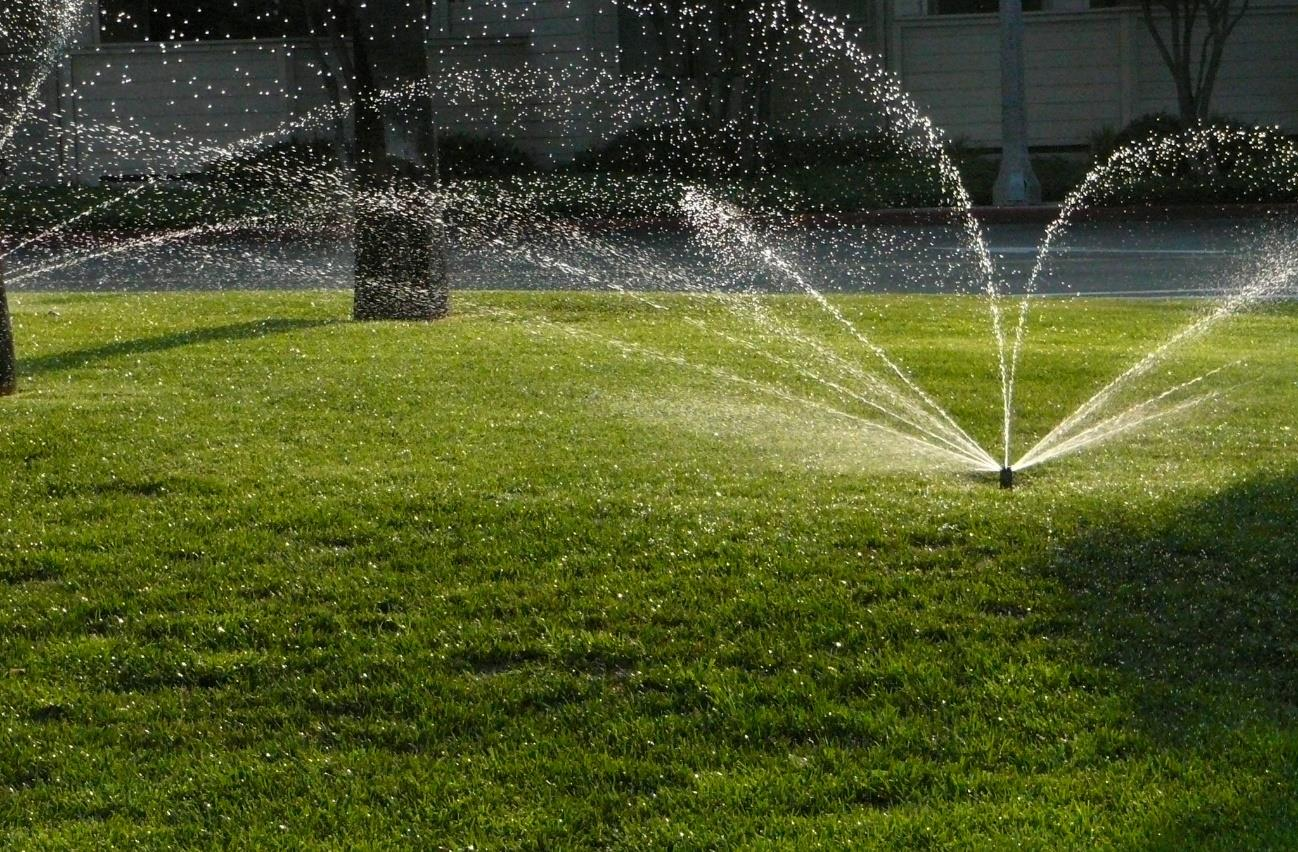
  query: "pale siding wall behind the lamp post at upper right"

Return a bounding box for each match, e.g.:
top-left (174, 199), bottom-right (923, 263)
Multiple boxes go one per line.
top-left (889, 4), bottom-right (1298, 147)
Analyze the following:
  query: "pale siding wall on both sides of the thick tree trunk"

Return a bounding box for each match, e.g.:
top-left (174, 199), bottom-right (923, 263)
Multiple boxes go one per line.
top-left (54, 0), bottom-right (628, 172)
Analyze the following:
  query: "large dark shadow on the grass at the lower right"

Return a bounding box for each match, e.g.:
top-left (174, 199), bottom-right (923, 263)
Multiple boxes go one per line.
top-left (1049, 474), bottom-right (1298, 848)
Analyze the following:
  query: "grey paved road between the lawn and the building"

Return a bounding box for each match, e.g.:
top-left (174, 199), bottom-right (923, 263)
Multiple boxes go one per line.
top-left (8, 219), bottom-right (1298, 296)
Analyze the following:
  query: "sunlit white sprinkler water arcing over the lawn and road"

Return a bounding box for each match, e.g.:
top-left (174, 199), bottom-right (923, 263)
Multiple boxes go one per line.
top-left (0, 0), bottom-right (1298, 477)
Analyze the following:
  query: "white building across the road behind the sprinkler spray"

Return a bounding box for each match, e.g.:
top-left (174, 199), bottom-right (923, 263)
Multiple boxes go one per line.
top-left (10, 0), bottom-right (1298, 181)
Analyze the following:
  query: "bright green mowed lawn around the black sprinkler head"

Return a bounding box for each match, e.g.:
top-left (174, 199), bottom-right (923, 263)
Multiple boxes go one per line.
top-left (0, 294), bottom-right (1298, 849)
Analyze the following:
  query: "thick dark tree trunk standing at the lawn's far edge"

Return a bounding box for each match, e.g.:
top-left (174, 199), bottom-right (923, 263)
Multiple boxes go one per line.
top-left (352, 0), bottom-right (450, 320)
